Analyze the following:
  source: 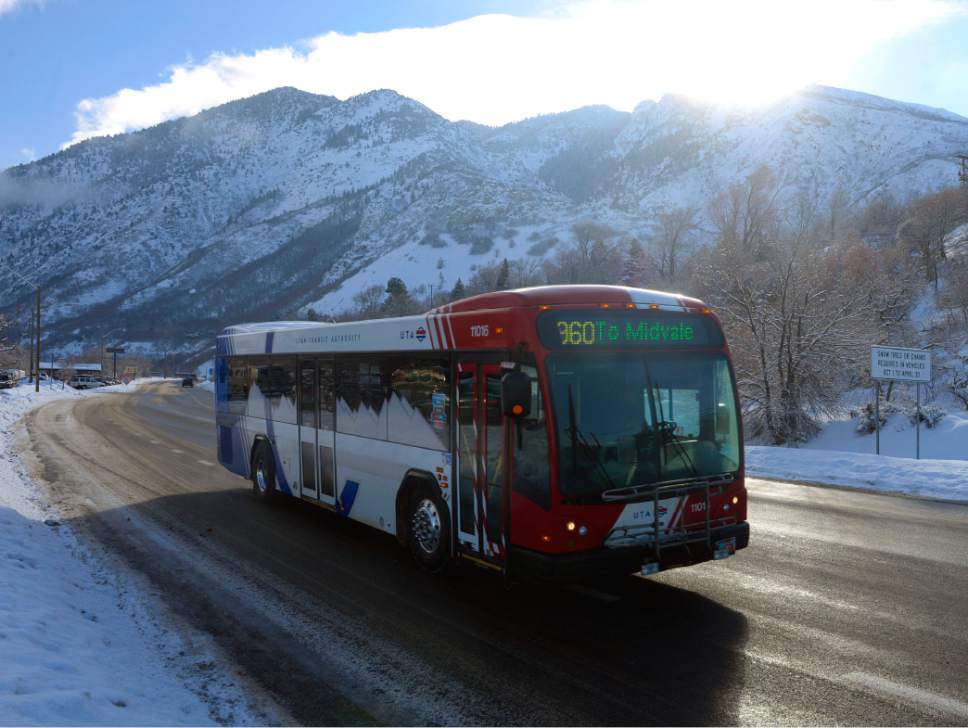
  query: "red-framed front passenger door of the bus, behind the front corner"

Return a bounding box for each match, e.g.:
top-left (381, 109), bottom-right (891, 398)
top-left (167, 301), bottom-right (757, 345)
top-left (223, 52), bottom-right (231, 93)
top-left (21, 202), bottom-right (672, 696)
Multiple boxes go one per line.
top-left (457, 362), bottom-right (505, 561)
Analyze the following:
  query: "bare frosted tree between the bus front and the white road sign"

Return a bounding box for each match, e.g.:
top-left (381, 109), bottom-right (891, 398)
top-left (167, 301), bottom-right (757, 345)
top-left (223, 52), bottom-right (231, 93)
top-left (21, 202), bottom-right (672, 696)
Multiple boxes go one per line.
top-left (697, 237), bottom-right (878, 444)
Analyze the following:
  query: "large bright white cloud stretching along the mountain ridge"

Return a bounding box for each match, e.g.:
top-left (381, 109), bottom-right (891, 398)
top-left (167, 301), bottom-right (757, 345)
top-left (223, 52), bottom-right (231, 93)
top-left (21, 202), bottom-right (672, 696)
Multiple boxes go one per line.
top-left (62, 0), bottom-right (964, 146)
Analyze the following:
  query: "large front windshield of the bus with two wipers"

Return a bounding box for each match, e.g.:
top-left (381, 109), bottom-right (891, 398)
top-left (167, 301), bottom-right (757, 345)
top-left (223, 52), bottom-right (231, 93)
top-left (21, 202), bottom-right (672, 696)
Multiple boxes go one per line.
top-left (547, 350), bottom-right (740, 499)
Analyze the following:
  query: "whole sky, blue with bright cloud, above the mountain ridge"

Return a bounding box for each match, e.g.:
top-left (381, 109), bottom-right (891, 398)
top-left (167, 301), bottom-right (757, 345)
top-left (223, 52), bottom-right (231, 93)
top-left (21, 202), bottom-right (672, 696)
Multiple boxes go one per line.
top-left (0, 0), bottom-right (968, 169)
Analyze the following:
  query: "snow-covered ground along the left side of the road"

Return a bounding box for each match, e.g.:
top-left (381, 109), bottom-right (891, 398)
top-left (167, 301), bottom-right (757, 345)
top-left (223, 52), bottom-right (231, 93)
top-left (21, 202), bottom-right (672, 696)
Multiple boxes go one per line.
top-left (0, 380), bottom-right (266, 725)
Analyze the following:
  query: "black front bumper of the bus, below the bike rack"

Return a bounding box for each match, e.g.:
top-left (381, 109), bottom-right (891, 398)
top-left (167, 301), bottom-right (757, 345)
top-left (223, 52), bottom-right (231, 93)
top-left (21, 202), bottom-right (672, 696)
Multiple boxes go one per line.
top-left (511, 521), bottom-right (750, 581)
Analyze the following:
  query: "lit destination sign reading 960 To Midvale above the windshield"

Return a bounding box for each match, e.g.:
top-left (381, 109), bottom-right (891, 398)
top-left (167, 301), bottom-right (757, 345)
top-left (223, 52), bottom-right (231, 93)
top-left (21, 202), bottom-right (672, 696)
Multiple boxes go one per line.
top-left (538, 310), bottom-right (723, 349)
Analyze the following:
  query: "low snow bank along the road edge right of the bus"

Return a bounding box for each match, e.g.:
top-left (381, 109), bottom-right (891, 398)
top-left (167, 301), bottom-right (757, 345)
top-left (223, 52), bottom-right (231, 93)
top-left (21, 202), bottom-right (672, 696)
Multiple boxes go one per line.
top-left (746, 445), bottom-right (968, 501)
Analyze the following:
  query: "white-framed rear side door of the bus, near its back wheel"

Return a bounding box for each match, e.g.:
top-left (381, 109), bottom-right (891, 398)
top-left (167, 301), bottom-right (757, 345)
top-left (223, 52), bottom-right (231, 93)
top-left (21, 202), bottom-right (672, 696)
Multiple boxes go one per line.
top-left (299, 359), bottom-right (336, 506)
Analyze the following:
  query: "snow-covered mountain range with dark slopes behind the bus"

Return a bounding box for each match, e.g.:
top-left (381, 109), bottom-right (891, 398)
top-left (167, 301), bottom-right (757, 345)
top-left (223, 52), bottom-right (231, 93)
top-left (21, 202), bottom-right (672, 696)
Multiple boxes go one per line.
top-left (0, 87), bottom-right (968, 351)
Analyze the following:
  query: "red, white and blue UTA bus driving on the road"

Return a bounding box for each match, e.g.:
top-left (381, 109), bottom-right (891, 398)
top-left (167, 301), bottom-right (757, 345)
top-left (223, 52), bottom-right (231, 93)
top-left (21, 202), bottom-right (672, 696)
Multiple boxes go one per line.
top-left (216, 285), bottom-right (749, 579)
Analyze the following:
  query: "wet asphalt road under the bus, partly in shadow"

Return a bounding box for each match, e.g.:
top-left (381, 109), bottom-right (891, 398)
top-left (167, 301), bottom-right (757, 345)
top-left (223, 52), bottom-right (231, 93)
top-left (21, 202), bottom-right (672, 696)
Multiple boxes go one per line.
top-left (18, 383), bottom-right (968, 725)
